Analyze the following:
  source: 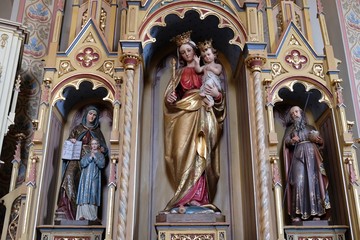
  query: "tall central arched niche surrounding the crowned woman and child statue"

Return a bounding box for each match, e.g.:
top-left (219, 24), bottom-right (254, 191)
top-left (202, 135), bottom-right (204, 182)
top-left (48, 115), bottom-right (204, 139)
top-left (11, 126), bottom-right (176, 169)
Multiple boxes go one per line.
top-left (134, 6), bottom-right (250, 239)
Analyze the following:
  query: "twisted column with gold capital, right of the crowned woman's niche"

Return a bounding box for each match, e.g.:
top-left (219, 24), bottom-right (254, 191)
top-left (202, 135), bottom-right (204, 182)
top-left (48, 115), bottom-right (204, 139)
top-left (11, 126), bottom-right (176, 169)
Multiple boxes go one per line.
top-left (246, 56), bottom-right (271, 240)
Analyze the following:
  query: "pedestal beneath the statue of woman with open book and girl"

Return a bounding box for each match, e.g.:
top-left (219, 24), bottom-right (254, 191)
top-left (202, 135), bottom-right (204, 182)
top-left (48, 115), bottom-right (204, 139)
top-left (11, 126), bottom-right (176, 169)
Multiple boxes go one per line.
top-left (38, 225), bottom-right (105, 240)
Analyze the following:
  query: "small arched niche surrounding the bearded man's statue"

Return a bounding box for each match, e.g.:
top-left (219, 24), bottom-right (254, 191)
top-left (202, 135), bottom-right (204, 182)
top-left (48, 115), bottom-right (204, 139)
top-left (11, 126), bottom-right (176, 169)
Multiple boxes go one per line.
top-left (273, 82), bottom-right (349, 229)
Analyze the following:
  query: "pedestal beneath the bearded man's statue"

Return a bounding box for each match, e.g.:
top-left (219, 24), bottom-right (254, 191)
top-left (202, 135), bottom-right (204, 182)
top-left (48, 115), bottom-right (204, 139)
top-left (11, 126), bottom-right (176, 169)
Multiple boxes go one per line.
top-left (284, 224), bottom-right (349, 240)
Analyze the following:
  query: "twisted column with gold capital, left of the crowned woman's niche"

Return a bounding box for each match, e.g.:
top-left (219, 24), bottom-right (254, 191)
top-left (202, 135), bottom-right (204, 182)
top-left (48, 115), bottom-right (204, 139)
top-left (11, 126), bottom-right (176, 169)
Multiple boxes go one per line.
top-left (117, 53), bottom-right (140, 240)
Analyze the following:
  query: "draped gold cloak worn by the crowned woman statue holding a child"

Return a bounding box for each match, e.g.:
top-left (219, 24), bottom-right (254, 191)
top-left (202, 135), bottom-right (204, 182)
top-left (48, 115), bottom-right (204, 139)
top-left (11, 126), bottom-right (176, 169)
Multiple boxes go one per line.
top-left (164, 69), bottom-right (226, 210)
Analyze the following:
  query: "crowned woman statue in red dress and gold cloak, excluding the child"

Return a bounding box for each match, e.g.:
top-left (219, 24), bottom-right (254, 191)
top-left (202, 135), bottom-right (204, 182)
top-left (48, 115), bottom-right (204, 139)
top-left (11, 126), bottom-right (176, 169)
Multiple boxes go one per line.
top-left (164, 31), bottom-right (225, 213)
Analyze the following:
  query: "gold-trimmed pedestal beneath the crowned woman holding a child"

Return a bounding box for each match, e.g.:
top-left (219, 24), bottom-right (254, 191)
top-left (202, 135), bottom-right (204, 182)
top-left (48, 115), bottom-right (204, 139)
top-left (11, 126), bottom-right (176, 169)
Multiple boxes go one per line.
top-left (155, 213), bottom-right (229, 240)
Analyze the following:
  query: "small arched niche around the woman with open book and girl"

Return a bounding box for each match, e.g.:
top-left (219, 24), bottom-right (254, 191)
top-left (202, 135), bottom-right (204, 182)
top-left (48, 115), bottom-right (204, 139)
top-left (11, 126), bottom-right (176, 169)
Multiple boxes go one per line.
top-left (41, 76), bottom-right (114, 225)
